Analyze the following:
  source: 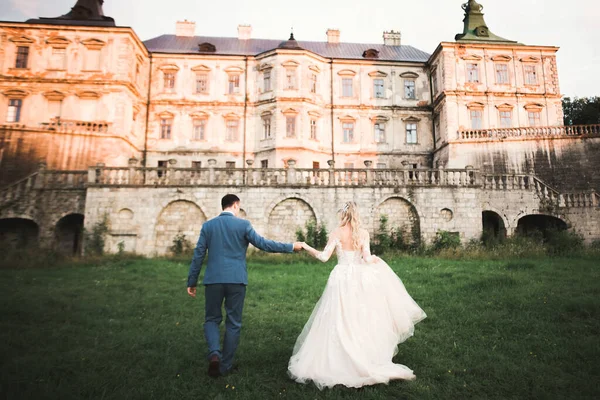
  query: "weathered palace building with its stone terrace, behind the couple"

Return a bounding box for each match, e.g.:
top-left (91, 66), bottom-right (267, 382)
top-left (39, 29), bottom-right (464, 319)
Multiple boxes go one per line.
top-left (0, 0), bottom-right (600, 254)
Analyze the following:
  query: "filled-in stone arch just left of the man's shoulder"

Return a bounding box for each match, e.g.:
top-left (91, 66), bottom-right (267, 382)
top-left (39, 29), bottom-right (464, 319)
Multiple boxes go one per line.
top-left (154, 200), bottom-right (206, 254)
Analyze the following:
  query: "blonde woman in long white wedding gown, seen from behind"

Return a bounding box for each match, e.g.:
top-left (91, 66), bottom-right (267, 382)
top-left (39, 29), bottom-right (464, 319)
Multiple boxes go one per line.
top-left (288, 202), bottom-right (426, 389)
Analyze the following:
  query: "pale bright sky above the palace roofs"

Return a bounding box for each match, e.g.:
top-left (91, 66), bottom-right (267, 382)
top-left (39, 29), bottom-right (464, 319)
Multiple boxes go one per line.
top-left (0, 0), bottom-right (600, 97)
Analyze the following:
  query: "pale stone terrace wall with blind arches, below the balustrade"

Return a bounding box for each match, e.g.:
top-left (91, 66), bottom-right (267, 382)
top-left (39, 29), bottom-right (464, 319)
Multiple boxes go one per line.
top-left (85, 187), bottom-right (482, 255)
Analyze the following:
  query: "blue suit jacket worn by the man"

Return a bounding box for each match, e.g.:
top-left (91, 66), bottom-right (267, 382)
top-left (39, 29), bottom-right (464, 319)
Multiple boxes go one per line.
top-left (187, 212), bottom-right (294, 287)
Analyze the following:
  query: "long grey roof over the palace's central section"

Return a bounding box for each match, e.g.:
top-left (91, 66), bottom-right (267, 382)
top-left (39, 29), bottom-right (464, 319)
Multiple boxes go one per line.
top-left (144, 35), bottom-right (429, 63)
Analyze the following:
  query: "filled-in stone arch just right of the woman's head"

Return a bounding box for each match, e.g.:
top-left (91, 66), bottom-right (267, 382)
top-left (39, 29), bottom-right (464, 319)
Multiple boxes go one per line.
top-left (372, 196), bottom-right (421, 244)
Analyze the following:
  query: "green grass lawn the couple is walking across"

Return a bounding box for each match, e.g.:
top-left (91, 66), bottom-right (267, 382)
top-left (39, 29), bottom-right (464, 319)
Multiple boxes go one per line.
top-left (0, 255), bottom-right (600, 400)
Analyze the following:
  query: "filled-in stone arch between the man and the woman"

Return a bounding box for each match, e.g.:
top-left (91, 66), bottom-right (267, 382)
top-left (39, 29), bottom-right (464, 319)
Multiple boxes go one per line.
top-left (267, 197), bottom-right (317, 242)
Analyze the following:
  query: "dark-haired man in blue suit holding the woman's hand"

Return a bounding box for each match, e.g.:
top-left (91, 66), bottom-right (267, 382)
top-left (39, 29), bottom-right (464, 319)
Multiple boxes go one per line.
top-left (187, 194), bottom-right (302, 377)
